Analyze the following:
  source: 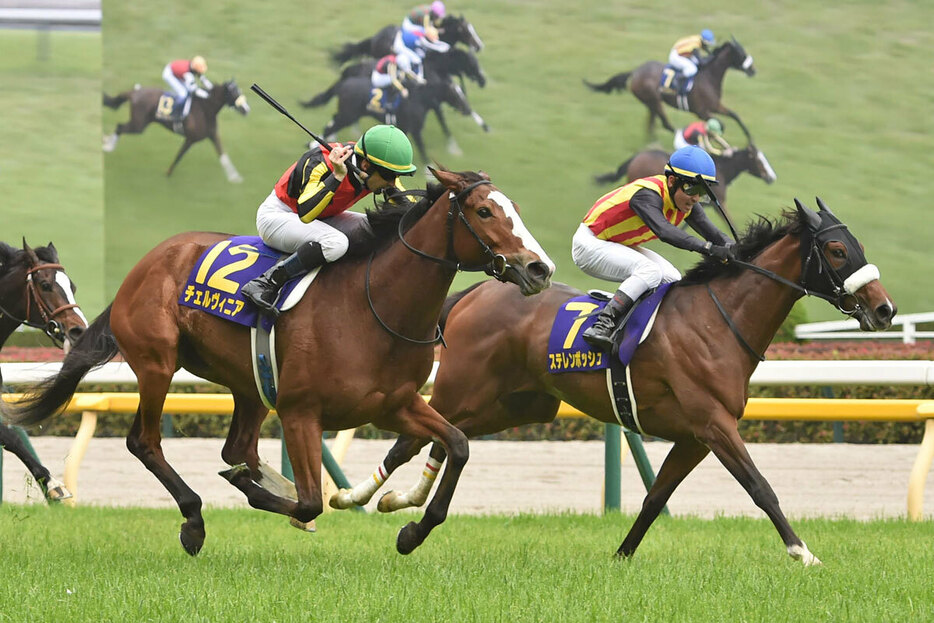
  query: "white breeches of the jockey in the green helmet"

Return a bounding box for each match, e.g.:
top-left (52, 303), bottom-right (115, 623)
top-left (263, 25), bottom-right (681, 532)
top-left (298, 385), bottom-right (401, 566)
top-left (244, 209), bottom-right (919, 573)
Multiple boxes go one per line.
top-left (256, 190), bottom-right (366, 262)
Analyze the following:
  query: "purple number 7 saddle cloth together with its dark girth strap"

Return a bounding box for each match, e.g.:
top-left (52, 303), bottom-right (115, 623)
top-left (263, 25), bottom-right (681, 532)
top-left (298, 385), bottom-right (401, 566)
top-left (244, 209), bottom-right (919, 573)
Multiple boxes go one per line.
top-left (548, 283), bottom-right (672, 434)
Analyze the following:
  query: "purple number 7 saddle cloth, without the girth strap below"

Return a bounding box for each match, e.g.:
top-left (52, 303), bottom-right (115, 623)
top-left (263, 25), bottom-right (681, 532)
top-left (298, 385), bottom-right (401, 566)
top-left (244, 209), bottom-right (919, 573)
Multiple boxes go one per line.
top-left (548, 283), bottom-right (671, 374)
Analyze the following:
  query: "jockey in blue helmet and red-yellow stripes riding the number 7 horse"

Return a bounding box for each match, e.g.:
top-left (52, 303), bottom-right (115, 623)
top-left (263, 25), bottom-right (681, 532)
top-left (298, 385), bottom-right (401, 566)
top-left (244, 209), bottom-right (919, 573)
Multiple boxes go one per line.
top-left (571, 146), bottom-right (733, 352)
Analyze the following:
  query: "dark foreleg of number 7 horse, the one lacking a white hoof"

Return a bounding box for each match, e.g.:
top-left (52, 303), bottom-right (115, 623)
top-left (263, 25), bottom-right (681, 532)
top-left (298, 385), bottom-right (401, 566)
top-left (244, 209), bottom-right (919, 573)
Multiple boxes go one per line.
top-left (616, 440), bottom-right (710, 558)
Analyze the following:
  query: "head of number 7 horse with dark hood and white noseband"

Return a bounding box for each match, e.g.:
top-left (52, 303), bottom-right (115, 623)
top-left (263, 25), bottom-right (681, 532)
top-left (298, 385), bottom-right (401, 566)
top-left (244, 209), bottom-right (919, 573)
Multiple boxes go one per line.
top-left (795, 197), bottom-right (897, 331)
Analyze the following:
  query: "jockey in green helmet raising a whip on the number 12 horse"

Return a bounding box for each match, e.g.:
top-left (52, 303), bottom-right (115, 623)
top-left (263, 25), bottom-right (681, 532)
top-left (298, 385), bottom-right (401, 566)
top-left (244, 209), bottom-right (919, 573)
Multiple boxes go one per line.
top-left (240, 125), bottom-right (416, 313)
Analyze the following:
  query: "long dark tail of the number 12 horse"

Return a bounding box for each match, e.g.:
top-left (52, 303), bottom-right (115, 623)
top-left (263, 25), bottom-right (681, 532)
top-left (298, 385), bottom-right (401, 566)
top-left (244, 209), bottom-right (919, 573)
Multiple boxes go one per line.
top-left (0, 306), bottom-right (120, 426)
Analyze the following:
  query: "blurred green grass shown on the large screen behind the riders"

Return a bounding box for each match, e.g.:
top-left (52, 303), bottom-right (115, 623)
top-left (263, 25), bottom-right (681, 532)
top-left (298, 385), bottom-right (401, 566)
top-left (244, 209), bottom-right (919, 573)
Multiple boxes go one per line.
top-left (103, 0), bottom-right (934, 320)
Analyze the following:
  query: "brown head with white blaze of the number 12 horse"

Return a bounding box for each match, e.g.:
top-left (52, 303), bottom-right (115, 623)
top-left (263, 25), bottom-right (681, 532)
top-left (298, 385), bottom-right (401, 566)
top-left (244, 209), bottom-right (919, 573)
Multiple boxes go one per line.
top-left (429, 167), bottom-right (555, 296)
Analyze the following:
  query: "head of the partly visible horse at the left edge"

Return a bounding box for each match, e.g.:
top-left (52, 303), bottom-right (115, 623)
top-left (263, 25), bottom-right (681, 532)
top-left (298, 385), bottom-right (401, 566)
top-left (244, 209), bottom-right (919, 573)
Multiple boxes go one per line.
top-left (11, 238), bottom-right (88, 353)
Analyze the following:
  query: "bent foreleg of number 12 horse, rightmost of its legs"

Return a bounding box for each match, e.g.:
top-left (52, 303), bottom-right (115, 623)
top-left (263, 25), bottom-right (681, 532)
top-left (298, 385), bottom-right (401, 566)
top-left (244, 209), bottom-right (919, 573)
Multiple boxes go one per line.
top-left (375, 394), bottom-right (469, 554)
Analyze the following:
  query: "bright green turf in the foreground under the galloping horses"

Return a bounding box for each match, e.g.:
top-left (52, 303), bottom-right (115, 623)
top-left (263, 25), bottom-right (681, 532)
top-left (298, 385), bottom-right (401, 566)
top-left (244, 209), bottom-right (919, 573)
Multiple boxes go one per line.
top-left (0, 505), bottom-right (934, 623)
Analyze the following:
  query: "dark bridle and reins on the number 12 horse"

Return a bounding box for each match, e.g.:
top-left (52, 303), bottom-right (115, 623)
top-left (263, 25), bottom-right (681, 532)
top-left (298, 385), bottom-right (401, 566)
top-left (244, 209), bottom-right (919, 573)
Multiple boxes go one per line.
top-left (365, 180), bottom-right (512, 344)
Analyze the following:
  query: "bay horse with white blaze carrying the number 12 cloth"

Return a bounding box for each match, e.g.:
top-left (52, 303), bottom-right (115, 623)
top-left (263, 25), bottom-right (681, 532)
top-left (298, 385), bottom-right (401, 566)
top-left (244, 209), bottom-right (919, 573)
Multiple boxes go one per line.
top-left (0, 169), bottom-right (553, 555)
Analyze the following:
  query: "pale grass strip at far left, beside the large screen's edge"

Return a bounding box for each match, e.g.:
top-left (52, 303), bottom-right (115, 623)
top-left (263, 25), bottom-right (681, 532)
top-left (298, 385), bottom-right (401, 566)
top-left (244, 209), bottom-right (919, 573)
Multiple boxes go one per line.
top-left (0, 30), bottom-right (104, 315)
